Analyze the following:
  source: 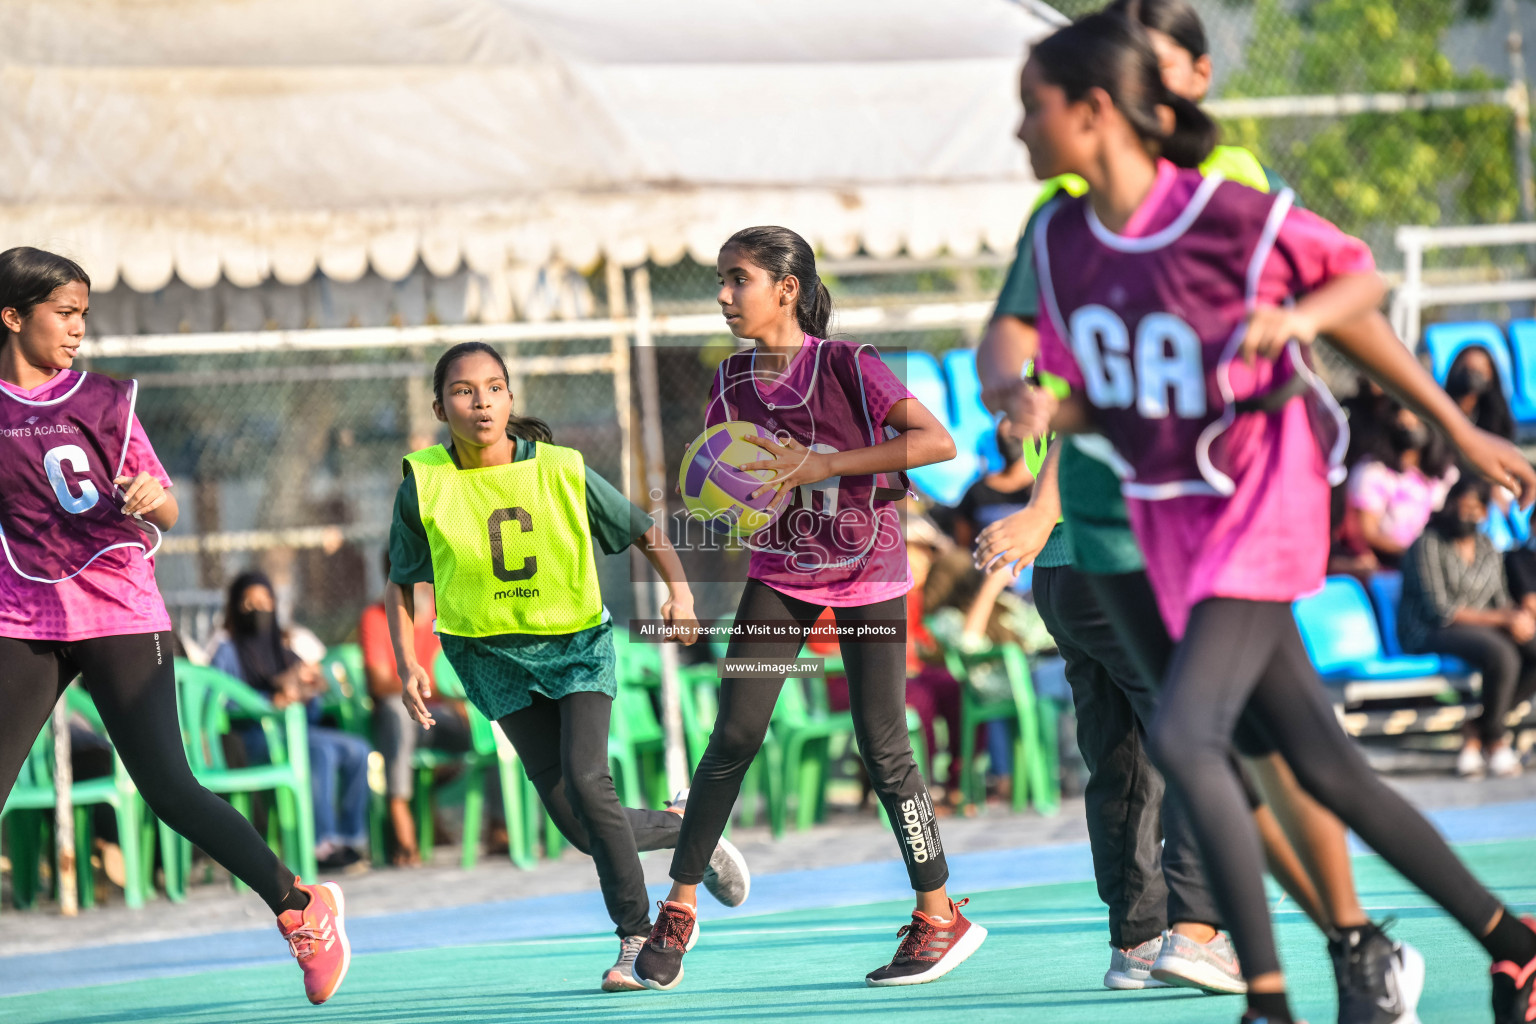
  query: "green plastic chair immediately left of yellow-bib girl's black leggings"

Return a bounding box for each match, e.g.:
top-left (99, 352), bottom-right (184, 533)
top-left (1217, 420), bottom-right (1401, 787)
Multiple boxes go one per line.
top-left (430, 651), bottom-right (542, 869)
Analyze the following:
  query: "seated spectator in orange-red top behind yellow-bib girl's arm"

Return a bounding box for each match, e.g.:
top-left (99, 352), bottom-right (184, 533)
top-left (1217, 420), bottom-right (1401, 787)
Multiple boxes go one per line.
top-left (358, 553), bottom-right (470, 867)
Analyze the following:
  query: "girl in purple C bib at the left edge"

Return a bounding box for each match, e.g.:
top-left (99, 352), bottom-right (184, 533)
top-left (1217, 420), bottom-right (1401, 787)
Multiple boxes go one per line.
top-left (0, 247), bottom-right (352, 1003)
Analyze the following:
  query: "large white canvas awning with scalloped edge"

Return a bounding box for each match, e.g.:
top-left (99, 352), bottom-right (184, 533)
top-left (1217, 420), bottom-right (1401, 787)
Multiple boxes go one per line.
top-left (0, 0), bottom-right (1049, 292)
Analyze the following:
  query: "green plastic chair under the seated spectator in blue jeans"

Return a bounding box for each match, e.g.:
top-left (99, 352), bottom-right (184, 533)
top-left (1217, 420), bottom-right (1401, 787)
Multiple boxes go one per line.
top-left (160, 659), bottom-right (318, 900)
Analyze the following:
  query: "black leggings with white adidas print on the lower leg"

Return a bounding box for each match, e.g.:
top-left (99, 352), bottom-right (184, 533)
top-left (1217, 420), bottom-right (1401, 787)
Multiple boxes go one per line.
top-left (671, 579), bottom-right (949, 892)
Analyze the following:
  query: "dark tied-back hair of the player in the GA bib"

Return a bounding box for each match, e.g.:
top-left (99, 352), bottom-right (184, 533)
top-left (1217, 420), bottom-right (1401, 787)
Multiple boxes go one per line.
top-left (1029, 5), bottom-right (1218, 167)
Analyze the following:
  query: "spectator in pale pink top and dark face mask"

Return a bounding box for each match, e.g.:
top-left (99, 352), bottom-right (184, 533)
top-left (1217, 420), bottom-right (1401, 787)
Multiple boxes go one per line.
top-left (1330, 404), bottom-right (1458, 571)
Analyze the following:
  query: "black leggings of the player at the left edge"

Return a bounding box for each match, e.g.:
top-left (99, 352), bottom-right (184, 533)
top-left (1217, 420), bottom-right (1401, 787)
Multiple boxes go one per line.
top-left (0, 633), bottom-right (293, 913)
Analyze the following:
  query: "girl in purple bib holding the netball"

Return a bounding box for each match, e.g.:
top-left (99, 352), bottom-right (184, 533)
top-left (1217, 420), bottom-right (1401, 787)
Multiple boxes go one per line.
top-left (634, 227), bottom-right (986, 989)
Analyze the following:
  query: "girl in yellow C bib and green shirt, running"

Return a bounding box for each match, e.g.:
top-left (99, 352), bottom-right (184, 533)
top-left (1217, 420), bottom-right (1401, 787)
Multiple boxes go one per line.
top-left (386, 342), bottom-right (750, 992)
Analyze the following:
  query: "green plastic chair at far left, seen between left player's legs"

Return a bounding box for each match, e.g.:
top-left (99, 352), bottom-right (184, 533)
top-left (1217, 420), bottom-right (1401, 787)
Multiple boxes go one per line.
top-left (0, 686), bottom-right (155, 909)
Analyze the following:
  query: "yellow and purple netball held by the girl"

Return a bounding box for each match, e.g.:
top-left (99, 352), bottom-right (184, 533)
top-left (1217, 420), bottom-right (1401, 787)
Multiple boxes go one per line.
top-left (677, 419), bottom-right (776, 537)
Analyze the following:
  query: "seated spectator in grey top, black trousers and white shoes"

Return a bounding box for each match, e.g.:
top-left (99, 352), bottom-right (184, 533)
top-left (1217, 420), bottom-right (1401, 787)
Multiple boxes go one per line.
top-left (1398, 474), bottom-right (1536, 777)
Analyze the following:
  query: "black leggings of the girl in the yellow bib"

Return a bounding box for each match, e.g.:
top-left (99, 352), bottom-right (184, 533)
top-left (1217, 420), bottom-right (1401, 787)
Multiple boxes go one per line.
top-left (501, 692), bottom-right (681, 938)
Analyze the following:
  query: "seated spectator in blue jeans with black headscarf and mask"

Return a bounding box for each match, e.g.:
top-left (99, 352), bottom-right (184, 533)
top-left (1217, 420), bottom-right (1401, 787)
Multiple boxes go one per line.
top-left (214, 573), bottom-right (372, 870)
